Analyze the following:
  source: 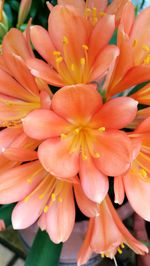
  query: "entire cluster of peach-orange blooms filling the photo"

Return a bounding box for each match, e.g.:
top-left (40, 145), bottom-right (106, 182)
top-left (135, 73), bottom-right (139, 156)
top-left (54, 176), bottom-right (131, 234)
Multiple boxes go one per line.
top-left (0, 0), bottom-right (150, 265)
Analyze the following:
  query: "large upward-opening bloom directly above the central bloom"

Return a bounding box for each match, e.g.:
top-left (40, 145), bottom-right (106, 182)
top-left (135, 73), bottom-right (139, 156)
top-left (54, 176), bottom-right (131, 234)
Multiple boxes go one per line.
top-left (27, 5), bottom-right (119, 87)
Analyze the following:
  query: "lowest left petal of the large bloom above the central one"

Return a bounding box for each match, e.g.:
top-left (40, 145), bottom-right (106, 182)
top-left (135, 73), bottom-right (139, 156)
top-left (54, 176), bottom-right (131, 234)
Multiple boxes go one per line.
top-left (27, 58), bottom-right (63, 86)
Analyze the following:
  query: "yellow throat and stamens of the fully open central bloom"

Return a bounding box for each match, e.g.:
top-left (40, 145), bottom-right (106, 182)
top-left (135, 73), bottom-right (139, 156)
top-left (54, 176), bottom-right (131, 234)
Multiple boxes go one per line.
top-left (61, 126), bottom-right (105, 160)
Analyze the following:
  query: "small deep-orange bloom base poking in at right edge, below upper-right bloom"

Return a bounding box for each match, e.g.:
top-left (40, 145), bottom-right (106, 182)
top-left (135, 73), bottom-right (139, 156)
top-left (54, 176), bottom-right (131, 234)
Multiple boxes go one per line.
top-left (130, 83), bottom-right (150, 105)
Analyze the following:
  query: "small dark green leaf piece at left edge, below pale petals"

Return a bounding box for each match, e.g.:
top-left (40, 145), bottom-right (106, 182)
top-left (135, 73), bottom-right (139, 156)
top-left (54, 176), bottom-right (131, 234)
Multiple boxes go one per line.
top-left (0, 204), bottom-right (15, 227)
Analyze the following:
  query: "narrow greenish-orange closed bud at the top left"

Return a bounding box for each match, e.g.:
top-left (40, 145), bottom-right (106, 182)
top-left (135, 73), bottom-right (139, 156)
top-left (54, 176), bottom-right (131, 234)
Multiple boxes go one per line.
top-left (17, 0), bottom-right (32, 27)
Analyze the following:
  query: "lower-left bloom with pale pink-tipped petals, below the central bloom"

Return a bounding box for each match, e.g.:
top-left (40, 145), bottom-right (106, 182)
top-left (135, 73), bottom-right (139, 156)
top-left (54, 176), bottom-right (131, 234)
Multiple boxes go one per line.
top-left (0, 160), bottom-right (98, 243)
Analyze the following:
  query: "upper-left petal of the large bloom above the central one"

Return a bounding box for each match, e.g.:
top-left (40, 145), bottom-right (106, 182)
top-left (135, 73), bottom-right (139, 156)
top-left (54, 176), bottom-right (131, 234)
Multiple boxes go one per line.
top-left (30, 26), bottom-right (56, 66)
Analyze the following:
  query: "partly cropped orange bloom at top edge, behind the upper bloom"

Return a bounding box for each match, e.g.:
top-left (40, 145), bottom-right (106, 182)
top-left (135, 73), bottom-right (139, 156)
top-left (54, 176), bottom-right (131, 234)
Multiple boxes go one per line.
top-left (54, 0), bottom-right (128, 26)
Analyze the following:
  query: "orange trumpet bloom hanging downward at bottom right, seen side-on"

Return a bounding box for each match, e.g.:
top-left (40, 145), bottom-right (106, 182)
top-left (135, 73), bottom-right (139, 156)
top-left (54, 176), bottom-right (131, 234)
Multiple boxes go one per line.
top-left (77, 196), bottom-right (148, 266)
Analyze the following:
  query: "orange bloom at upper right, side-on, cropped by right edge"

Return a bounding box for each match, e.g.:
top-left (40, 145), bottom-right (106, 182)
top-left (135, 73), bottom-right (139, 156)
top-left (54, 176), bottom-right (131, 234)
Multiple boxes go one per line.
top-left (105, 2), bottom-right (150, 99)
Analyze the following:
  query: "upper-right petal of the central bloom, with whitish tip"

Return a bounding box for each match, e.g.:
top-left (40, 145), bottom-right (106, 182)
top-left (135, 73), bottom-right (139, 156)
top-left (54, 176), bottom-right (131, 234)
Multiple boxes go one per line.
top-left (91, 97), bottom-right (138, 129)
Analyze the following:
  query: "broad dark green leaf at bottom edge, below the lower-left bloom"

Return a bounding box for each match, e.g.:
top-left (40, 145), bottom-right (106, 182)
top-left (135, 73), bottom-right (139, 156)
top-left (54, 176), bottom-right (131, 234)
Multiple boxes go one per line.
top-left (25, 230), bottom-right (62, 266)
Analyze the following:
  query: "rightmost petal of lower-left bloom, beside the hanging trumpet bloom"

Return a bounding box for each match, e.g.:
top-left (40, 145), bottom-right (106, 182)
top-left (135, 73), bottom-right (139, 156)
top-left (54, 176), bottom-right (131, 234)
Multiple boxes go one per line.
top-left (74, 183), bottom-right (98, 217)
